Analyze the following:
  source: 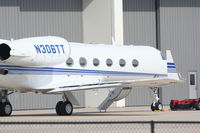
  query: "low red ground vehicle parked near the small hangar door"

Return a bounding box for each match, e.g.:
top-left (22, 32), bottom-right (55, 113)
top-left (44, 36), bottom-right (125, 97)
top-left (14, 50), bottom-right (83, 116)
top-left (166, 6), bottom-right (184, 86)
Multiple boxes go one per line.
top-left (170, 98), bottom-right (200, 111)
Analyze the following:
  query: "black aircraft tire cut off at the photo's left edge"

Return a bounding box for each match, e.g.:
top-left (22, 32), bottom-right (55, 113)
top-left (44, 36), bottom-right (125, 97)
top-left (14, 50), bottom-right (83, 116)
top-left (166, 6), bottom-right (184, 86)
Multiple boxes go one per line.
top-left (0, 102), bottom-right (12, 116)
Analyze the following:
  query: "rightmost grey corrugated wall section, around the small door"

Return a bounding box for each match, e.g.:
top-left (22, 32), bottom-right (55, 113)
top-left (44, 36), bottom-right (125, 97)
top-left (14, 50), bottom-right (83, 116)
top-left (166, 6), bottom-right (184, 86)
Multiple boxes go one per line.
top-left (160, 0), bottom-right (200, 104)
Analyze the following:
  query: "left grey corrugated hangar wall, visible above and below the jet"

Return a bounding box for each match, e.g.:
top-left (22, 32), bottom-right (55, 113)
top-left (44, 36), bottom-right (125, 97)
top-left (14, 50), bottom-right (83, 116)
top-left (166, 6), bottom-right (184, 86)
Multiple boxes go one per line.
top-left (0, 0), bottom-right (85, 109)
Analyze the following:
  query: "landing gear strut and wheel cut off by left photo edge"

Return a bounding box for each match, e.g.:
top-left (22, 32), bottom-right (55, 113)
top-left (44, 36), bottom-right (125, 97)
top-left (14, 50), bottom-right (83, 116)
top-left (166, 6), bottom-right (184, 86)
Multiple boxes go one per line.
top-left (0, 90), bottom-right (12, 116)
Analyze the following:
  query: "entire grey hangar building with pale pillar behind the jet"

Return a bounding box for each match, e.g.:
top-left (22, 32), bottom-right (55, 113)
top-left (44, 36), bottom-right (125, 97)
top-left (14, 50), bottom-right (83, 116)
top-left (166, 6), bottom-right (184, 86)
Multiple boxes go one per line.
top-left (0, 0), bottom-right (200, 110)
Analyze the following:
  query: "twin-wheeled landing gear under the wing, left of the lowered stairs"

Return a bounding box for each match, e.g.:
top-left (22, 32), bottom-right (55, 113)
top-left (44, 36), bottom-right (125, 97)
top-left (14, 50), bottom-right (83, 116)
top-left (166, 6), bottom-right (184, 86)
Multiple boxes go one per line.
top-left (56, 94), bottom-right (73, 115)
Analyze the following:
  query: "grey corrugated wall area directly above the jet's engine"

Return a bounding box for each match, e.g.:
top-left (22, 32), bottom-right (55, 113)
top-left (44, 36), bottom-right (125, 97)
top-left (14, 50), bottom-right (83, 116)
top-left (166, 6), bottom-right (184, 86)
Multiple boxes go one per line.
top-left (0, 0), bottom-right (83, 42)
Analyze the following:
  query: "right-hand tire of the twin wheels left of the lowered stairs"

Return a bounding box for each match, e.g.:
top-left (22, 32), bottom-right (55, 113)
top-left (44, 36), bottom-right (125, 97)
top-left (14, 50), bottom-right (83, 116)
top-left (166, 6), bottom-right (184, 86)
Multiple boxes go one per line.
top-left (60, 101), bottom-right (73, 115)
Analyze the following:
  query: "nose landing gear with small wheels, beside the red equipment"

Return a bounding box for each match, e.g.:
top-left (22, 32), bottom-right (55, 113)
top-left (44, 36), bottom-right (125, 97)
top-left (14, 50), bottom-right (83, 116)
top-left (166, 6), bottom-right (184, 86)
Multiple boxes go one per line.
top-left (150, 88), bottom-right (163, 111)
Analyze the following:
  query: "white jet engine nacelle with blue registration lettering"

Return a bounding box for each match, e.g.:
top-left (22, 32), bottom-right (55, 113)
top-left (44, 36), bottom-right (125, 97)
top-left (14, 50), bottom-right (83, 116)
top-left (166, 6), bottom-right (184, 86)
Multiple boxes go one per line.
top-left (0, 36), bottom-right (70, 66)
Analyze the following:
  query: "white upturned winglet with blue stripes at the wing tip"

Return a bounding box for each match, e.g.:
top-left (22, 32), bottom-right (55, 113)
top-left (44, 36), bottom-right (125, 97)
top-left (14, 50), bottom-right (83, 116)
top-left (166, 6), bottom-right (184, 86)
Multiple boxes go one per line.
top-left (166, 50), bottom-right (180, 80)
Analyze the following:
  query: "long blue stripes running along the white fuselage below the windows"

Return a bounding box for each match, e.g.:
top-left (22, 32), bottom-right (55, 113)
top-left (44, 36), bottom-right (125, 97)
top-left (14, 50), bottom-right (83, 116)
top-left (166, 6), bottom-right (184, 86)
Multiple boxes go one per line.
top-left (0, 65), bottom-right (167, 76)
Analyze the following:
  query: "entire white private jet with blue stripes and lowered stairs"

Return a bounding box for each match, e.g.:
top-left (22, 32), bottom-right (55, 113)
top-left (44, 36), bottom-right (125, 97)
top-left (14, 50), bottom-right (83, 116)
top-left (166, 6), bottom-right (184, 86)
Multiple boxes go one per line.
top-left (0, 36), bottom-right (181, 116)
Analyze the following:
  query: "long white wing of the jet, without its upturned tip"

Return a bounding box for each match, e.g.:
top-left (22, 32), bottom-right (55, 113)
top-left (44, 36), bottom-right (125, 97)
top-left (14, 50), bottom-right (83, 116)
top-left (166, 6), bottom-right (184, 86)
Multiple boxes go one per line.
top-left (48, 78), bottom-right (181, 93)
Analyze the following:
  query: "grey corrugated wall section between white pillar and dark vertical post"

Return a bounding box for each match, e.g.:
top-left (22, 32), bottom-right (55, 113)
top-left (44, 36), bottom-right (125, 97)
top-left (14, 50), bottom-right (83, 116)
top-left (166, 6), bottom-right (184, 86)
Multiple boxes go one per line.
top-left (123, 0), bottom-right (156, 106)
